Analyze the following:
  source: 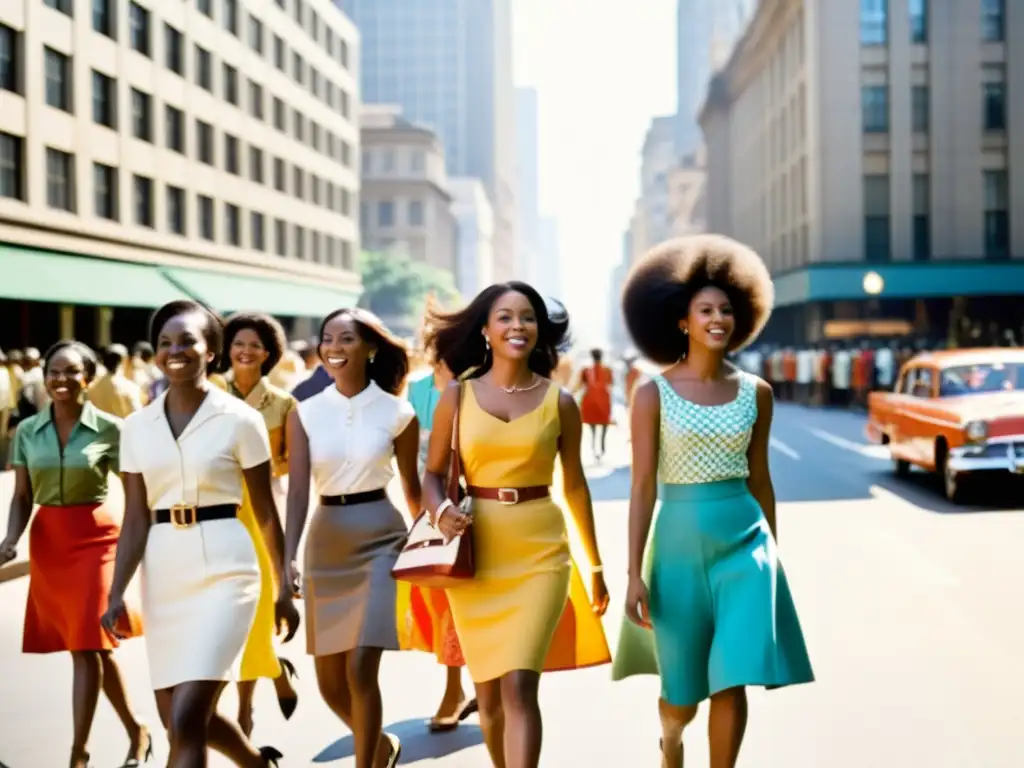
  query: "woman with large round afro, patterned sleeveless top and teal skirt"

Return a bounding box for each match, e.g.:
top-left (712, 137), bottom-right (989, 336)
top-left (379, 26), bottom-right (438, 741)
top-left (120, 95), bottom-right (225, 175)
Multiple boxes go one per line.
top-left (613, 236), bottom-right (814, 768)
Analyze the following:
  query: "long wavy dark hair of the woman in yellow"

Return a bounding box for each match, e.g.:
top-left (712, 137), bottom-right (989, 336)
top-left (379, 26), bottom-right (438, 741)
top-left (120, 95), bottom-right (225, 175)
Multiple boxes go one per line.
top-left (424, 281), bottom-right (571, 378)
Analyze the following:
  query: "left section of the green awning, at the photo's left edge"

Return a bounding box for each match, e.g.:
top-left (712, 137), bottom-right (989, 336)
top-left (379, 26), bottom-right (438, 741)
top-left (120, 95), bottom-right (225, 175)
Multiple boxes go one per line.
top-left (0, 244), bottom-right (188, 308)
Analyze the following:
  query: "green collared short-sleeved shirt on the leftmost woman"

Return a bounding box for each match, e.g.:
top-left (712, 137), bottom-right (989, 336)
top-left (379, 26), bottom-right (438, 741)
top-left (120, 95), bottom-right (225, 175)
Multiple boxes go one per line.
top-left (10, 402), bottom-right (121, 507)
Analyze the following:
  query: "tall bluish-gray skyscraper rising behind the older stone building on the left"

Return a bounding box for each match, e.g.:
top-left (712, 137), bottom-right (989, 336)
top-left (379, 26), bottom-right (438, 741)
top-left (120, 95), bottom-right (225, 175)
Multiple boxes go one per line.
top-left (340, 0), bottom-right (516, 280)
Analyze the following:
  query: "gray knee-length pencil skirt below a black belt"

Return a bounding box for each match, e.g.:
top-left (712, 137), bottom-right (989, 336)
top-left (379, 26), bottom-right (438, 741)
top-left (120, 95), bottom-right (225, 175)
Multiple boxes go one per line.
top-left (303, 499), bottom-right (409, 656)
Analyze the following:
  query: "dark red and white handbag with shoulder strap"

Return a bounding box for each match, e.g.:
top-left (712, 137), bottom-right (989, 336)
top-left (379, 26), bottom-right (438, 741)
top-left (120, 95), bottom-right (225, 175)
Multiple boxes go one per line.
top-left (391, 384), bottom-right (476, 589)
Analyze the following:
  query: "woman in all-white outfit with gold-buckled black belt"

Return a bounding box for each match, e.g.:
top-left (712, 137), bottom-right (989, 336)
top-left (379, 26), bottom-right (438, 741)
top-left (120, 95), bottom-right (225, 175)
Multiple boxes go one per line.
top-left (102, 301), bottom-right (298, 768)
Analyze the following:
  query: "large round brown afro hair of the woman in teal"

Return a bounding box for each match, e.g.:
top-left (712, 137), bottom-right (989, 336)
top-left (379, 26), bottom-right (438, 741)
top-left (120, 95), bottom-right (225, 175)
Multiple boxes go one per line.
top-left (623, 234), bottom-right (774, 366)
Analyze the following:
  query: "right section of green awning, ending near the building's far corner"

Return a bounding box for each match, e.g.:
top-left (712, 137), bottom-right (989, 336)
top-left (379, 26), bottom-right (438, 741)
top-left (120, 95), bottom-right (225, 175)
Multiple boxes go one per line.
top-left (163, 267), bottom-right (358, 317)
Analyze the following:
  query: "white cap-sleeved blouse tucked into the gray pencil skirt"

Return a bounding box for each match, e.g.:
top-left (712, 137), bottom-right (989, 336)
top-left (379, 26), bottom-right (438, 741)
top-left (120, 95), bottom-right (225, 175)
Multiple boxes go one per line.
top-left (298, 382), bottom-right (416, 496)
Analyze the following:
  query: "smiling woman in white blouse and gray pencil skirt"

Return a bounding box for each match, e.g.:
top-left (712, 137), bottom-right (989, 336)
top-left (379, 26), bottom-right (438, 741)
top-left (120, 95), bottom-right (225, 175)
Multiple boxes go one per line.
top-left (285, 309), bottom-right (420, 768)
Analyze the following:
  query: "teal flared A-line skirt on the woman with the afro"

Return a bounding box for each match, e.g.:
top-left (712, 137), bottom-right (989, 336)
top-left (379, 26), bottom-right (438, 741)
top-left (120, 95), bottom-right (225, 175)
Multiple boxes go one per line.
top-left (612, 479), bottom-right (814, 707)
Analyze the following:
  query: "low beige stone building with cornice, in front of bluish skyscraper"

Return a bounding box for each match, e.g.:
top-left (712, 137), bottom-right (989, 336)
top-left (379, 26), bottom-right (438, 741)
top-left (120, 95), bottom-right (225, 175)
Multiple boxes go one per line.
top-left (359, 104), bottom-right (456, 276)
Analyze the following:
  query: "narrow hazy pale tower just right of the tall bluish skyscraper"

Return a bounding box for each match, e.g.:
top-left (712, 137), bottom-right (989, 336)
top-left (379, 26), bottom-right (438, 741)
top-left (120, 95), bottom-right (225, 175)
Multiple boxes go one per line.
top-left (515, 88), bottom-right (543, 283)
